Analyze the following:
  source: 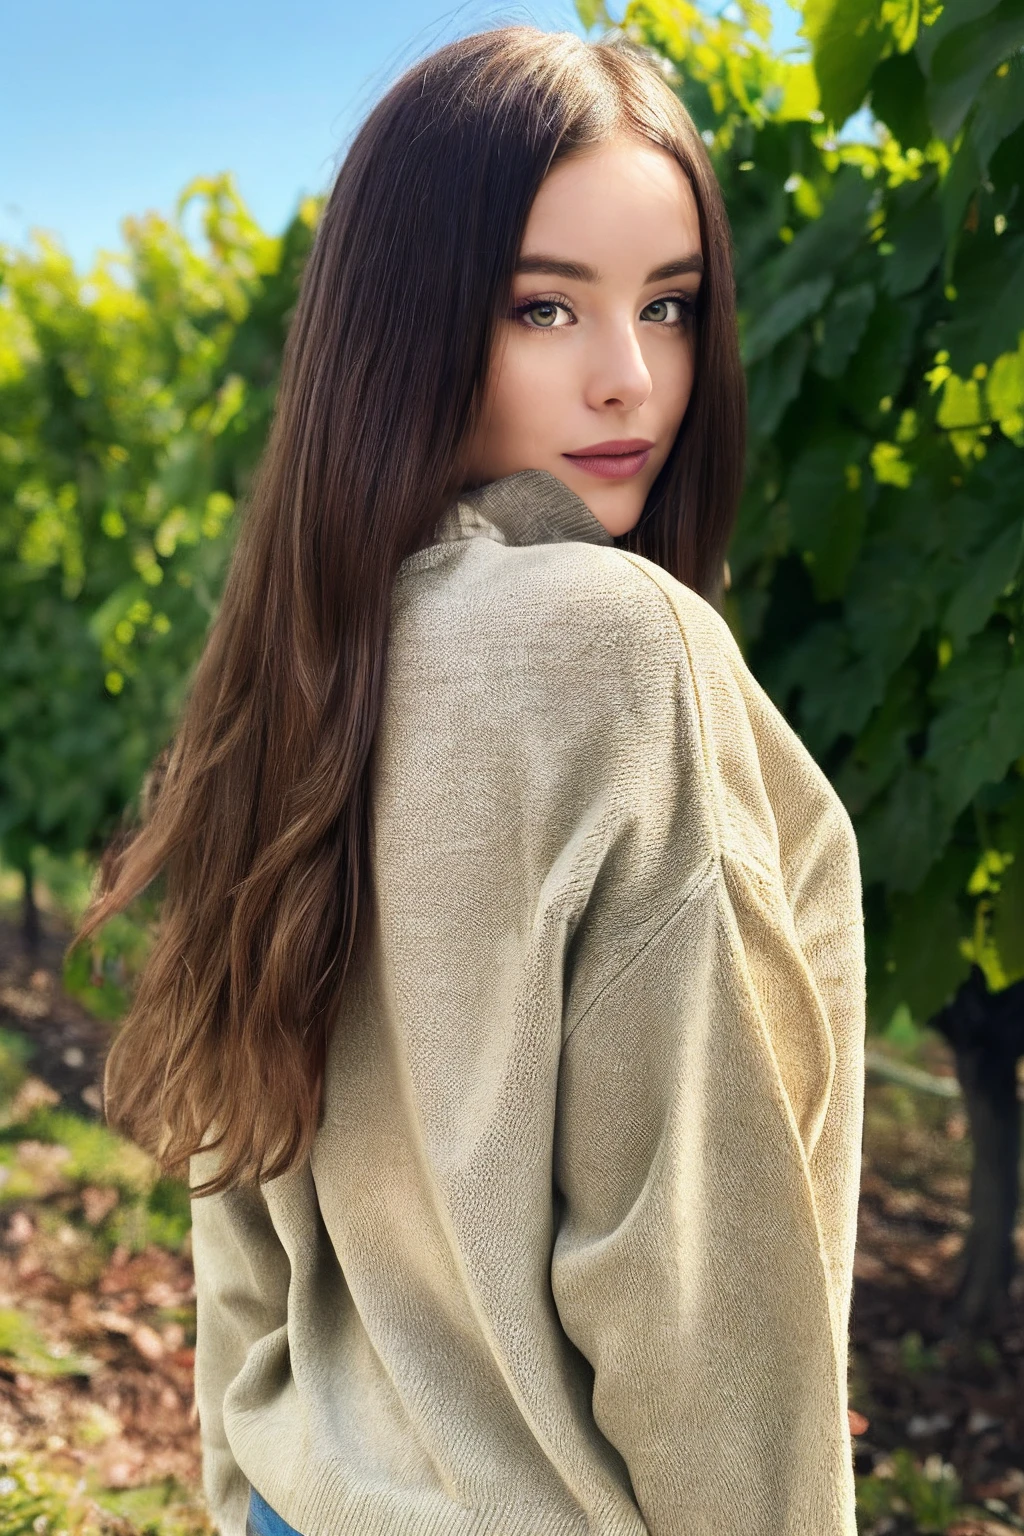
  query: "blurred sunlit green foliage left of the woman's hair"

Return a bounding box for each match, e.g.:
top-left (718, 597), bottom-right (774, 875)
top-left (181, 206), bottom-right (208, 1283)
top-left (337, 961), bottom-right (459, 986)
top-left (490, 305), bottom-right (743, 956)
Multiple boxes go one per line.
top-left (0, 177), bottom-right (318, 868)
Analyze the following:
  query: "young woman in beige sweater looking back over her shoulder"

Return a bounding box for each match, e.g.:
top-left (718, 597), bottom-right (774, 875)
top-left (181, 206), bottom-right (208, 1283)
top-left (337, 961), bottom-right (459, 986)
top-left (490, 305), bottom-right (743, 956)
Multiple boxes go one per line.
top-left (83, 28), bottom-right (864, 1536)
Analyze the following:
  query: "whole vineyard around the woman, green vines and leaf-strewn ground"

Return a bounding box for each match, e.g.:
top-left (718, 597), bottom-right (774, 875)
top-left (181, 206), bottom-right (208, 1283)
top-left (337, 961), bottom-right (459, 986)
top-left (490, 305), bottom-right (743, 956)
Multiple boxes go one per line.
top-left (0, 0), bottom-right (1024, 1536)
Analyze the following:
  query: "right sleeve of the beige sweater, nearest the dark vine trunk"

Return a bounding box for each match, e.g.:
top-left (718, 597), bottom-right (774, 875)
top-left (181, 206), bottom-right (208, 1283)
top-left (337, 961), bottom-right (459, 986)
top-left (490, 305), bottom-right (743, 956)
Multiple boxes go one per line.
top-left (551, 559), bottom-right (864, 1536)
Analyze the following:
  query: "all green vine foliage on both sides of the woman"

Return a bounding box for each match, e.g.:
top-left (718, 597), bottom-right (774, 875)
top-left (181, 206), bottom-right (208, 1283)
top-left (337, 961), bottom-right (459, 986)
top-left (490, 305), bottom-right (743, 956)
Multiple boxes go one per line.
top-left (0, 0), bottom-right (1024, 1044)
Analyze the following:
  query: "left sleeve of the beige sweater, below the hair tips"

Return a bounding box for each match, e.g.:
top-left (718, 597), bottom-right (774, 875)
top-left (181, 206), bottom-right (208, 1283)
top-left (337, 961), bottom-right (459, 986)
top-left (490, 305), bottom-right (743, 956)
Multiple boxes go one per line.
top-left (189, 1150), bottom-right (290, 1536)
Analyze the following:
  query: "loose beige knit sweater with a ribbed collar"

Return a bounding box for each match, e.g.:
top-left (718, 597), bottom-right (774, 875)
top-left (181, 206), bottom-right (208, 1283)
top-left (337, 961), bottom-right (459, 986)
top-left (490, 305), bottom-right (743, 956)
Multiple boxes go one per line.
top-left (192, 470), bottom-right (864, 1536)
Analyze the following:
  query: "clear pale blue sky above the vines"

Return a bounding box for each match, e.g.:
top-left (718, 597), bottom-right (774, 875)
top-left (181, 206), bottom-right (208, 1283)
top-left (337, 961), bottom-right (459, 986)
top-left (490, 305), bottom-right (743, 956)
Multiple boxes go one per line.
top-left (0, 0), bottom-right (800, 270)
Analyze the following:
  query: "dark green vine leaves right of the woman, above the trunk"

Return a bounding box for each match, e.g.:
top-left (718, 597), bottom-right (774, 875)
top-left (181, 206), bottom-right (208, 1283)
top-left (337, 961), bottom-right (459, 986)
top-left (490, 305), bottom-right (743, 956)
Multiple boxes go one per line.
top-left (601, 0), bottom-right (1024, 1028)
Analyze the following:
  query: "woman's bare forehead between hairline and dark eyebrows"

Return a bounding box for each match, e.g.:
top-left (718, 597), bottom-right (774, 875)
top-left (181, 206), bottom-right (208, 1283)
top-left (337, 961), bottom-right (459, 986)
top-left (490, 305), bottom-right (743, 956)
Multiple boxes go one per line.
top-left (522, 138), bottom-right (700, 270)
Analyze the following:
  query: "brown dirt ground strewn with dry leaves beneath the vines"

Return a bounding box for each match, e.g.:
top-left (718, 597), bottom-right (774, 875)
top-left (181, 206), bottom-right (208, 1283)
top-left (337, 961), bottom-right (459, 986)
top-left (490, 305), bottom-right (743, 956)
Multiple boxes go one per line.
top-left (0, 919), bottom-right (1024, 1536)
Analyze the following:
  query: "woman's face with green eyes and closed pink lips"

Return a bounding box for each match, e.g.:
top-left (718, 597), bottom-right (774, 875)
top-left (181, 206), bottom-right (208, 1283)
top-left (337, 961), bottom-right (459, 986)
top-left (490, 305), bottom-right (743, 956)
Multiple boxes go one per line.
top-left (470, 138), bottom-right (702, 538)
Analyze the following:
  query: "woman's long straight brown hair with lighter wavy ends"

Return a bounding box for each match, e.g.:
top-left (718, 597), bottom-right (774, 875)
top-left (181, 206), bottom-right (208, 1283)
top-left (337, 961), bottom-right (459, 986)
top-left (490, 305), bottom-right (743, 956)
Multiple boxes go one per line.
top-left (74, 26), bottom-right (745, 1193)
